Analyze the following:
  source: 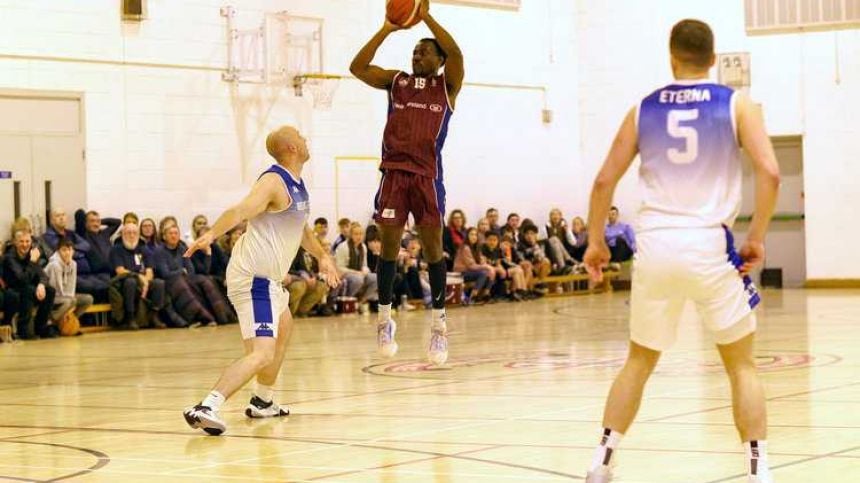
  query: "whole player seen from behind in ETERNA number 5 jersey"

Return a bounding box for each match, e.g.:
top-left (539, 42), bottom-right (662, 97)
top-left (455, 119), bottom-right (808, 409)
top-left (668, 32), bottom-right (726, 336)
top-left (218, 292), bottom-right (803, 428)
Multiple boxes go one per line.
top-left (585, 20), bottom-right (779, 483)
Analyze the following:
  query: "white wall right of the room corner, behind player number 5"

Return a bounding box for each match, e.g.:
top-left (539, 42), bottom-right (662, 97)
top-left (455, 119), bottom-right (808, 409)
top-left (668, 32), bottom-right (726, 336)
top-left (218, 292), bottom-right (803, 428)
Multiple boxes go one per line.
top-left (577, 0), bottom-right (860, 279)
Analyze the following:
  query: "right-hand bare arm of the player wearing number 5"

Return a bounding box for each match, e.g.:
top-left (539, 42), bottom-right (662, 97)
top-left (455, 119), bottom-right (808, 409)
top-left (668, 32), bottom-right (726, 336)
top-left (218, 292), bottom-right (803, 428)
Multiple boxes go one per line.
top-left (736, 94), bottom-right (779, 273)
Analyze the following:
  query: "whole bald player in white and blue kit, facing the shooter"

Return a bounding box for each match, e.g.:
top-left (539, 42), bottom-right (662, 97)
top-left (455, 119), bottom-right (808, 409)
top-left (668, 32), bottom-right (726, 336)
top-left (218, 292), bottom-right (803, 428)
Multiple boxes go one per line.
top-left (183, 126), bottom-right (340, 436)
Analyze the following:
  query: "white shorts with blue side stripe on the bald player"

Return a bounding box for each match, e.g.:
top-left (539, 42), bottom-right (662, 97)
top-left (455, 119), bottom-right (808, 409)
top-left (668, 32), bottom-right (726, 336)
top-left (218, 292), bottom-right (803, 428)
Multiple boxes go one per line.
top-left (227, 276), bottom-right (290, 339)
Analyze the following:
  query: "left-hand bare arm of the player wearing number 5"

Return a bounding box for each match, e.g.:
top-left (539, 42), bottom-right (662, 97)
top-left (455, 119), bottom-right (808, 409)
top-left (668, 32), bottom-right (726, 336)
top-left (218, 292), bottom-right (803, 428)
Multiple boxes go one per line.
top-left (583, 109), bottom-right (639, 281)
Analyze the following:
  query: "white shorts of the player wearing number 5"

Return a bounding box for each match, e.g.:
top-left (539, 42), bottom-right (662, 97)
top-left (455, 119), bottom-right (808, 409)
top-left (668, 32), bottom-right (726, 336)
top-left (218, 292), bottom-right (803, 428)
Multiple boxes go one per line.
top-left (630, 227), bottom-right (761, 351)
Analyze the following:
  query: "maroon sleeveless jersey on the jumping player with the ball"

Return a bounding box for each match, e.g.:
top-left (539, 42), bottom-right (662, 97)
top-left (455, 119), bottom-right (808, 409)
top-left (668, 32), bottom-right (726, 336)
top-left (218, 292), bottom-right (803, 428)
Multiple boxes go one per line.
top-left (381, 72), bottom-right (454, 181)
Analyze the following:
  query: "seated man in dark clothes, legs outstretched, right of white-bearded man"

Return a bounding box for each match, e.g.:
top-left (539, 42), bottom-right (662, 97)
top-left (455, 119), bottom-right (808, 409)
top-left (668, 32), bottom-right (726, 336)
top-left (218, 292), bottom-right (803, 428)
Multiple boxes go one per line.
top-left (154, 225), bottom-right (217, 326)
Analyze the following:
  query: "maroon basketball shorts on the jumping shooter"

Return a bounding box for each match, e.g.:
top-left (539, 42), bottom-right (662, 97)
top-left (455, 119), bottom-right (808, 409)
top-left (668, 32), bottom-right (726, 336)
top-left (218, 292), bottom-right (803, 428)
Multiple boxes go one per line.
top-left (373, 169), bottom-right (445, 228)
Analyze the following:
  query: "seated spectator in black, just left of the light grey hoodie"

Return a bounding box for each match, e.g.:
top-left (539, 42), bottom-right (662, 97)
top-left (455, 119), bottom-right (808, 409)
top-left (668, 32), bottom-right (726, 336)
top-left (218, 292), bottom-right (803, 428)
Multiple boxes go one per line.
top-left (3, 230), bottom-right (60, 340)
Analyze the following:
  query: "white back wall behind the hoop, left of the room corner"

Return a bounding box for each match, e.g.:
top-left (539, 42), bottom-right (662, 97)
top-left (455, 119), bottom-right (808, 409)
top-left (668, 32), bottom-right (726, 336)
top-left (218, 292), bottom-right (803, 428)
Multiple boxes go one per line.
top-left (0, 0), bottom-right (586, 234)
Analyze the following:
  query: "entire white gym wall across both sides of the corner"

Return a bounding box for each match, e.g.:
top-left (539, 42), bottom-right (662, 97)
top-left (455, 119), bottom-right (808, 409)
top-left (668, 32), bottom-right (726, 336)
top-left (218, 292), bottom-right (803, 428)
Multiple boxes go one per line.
top-left (0, 0), bottom-right (860, 278)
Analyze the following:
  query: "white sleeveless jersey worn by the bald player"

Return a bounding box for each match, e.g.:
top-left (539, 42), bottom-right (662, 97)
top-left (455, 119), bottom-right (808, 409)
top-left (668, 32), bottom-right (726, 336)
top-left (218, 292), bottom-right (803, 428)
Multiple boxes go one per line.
top-left (227, 164), bottom-right (310, 291)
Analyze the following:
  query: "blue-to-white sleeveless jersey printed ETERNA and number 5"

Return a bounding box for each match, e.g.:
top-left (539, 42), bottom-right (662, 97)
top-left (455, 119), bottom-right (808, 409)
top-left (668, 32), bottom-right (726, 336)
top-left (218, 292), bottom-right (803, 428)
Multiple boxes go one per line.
top-left (637, 81), bottom-right (743, 231)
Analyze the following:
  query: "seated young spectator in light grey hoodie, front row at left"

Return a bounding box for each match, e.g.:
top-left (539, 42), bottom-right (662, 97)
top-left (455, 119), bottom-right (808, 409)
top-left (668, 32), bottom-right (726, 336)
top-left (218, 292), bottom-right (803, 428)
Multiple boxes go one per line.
top-left (45, 238), bottom-right (93, 328)
